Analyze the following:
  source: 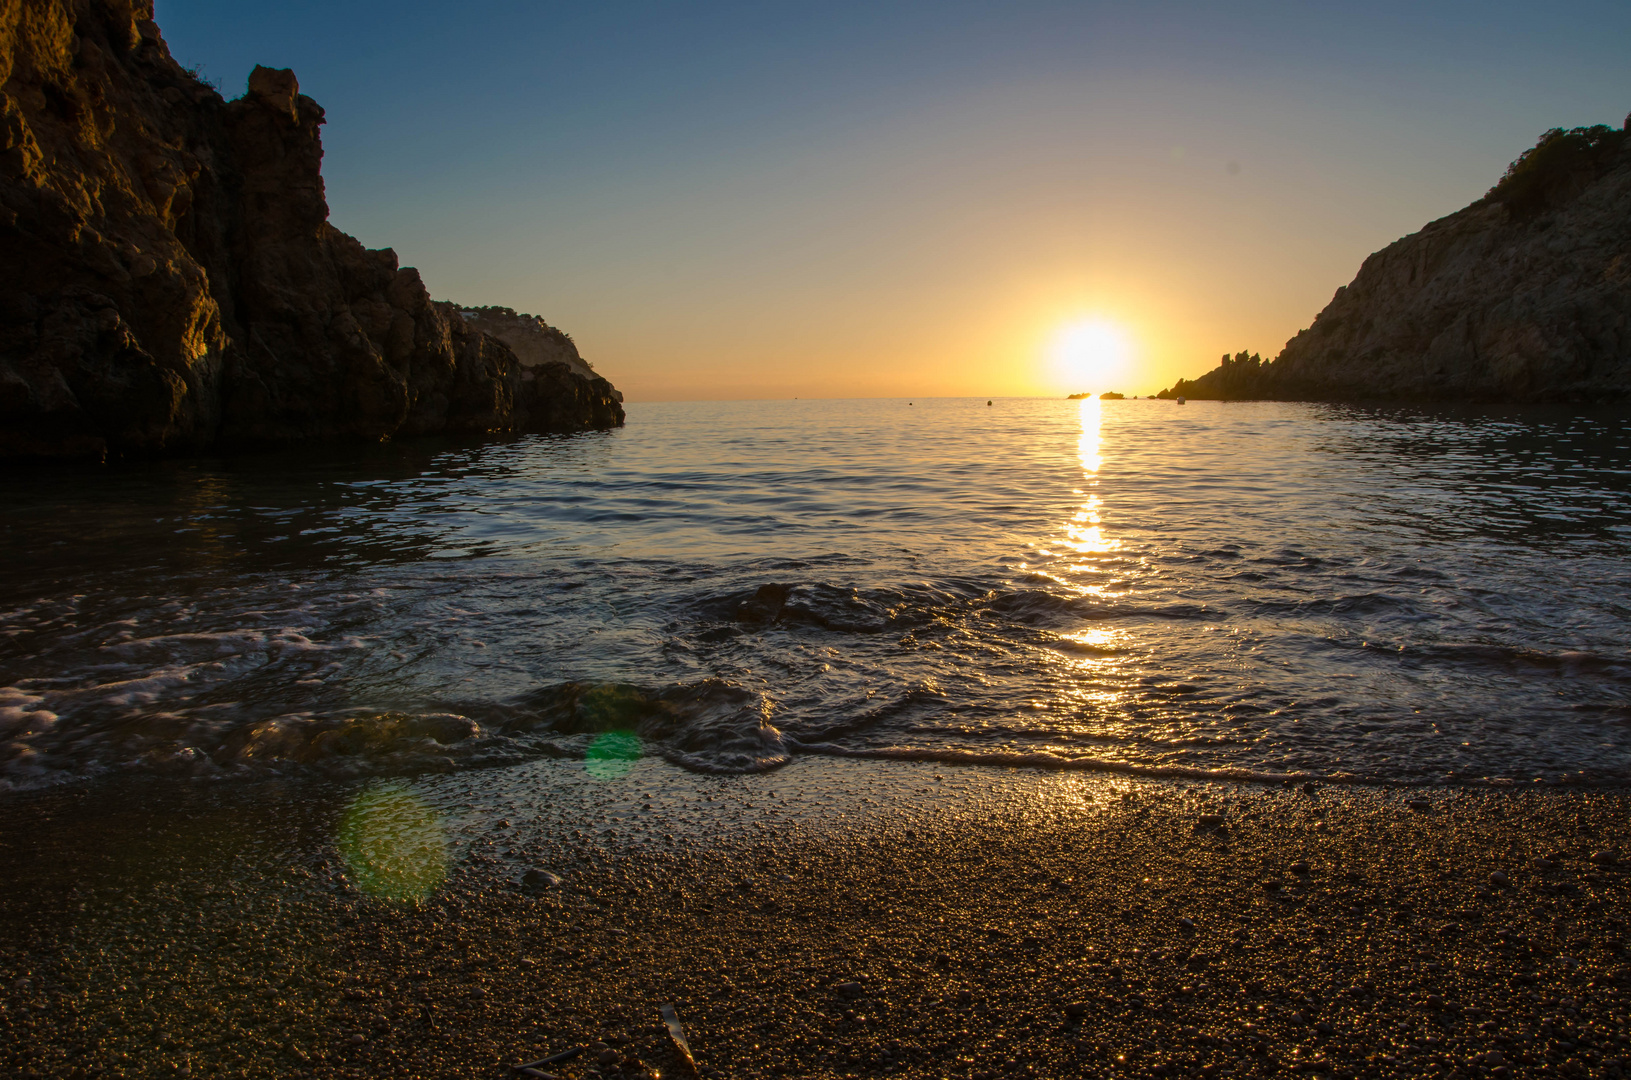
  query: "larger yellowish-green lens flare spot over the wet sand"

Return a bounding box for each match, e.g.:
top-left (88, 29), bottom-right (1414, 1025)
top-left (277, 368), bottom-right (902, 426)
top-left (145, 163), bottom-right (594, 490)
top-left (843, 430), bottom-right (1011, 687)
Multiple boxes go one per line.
top-left (339, 783), bottom-right (447, 904)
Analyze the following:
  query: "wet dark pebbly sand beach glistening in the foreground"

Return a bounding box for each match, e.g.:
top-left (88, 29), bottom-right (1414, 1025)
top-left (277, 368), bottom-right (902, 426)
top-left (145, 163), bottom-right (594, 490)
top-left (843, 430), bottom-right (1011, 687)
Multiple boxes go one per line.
top-left (0, 760), bottom-right (1631, 1078)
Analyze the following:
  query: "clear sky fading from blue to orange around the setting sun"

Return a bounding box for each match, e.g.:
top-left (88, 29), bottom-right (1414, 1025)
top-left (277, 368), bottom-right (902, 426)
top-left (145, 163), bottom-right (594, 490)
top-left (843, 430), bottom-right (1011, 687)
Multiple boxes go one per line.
top-left (158, 0), bottom-right (1631, 401)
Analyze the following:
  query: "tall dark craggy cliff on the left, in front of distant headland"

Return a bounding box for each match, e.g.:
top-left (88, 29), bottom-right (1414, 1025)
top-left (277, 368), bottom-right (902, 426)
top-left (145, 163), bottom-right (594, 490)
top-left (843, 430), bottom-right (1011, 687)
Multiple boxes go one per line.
top-left (0, 0), bottom-right (623, 458)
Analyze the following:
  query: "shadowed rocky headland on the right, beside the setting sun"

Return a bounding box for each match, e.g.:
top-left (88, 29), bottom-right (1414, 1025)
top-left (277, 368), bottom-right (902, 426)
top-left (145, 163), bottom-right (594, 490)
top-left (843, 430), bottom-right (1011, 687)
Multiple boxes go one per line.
top-left (1161, 119), bottom-right (1631, 401)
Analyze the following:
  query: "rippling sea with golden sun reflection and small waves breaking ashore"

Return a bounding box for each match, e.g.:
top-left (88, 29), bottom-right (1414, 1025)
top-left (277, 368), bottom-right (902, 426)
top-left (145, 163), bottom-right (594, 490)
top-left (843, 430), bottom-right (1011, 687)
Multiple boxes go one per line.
top-left (0, 400), bottom-right (1631, 788)
